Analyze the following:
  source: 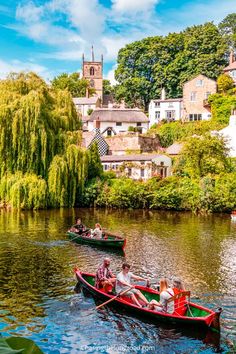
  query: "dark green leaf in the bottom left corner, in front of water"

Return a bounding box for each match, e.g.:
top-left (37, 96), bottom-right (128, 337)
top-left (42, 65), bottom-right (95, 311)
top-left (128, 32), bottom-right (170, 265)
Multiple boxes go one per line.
top-left (0, 337), bottom-right (43, 354)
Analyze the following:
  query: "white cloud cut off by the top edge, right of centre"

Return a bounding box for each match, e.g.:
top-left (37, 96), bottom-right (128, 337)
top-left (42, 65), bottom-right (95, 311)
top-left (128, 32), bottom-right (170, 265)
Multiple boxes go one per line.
top-left (112, 0), bottom-right (158, 14)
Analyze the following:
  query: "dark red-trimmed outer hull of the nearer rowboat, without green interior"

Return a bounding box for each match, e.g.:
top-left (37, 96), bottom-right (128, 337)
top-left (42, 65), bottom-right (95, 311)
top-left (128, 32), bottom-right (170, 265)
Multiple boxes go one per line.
top-left (75, 269), bottom-right (220, 330)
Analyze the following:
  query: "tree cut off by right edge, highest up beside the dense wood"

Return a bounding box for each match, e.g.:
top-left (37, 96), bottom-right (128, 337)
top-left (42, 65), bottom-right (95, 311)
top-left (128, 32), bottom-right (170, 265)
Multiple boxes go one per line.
top-left (218, 13), bottom-right (236, 50)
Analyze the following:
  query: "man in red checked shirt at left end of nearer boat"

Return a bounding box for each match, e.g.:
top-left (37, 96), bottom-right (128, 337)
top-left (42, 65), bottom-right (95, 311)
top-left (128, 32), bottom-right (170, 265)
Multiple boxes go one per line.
top-left (95, 257), bottom-right (116, 293)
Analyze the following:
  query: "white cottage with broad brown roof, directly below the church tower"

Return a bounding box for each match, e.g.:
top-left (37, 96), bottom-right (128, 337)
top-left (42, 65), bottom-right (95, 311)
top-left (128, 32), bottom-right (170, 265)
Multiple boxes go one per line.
top-left (87, 107), bottom-right (149, 136)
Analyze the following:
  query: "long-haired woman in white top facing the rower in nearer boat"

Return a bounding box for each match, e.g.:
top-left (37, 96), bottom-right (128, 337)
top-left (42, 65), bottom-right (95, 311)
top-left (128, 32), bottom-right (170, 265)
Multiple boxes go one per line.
top-left (149, 278), bottom-right (174, 313)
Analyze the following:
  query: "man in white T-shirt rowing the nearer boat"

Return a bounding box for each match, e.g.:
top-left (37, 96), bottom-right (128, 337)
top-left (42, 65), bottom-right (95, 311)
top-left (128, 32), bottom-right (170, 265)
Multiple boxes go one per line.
top-left (116, 263), bottom-right (149, 307)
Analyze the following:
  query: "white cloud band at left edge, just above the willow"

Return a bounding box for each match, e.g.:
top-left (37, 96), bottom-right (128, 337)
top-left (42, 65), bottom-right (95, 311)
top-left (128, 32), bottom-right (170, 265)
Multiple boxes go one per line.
top-left (0, 59), bottom-right (53, 80)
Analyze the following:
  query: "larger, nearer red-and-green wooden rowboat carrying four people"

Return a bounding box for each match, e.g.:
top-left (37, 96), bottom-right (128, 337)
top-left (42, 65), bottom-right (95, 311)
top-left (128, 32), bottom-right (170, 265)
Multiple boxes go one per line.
top-left (74, 269), bottom-right (222, 330)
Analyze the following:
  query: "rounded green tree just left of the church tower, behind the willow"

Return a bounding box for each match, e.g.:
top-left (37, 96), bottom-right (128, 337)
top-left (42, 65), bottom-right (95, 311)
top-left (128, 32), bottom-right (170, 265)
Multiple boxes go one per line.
top-left (52, 73), bottom-right (95, 97)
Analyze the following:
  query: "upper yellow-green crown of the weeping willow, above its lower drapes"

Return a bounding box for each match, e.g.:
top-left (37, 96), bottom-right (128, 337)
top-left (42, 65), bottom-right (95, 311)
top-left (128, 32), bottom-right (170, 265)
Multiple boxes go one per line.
top-left (0, 73), bottom-right (80, 178)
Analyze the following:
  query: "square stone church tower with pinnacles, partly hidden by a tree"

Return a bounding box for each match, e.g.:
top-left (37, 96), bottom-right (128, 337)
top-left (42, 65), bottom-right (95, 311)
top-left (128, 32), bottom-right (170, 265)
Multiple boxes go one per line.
top-left (82, 46), bottom-right (103, 100)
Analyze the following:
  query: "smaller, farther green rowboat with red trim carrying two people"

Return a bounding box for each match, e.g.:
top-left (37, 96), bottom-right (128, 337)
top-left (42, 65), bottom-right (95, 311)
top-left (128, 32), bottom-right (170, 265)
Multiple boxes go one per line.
top-left (67, 230), bottom-right (126, 249)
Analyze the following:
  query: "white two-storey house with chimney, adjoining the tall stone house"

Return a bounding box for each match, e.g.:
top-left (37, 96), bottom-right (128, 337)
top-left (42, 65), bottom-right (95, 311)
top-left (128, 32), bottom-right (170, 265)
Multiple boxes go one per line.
top-left (148, 89), bottom-right (183, 127)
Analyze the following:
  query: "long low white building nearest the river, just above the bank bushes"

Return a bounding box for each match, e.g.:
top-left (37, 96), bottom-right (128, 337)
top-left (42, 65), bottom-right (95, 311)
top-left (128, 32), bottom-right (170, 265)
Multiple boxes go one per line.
top-left (101, 154), bottom-right (171, 180)
